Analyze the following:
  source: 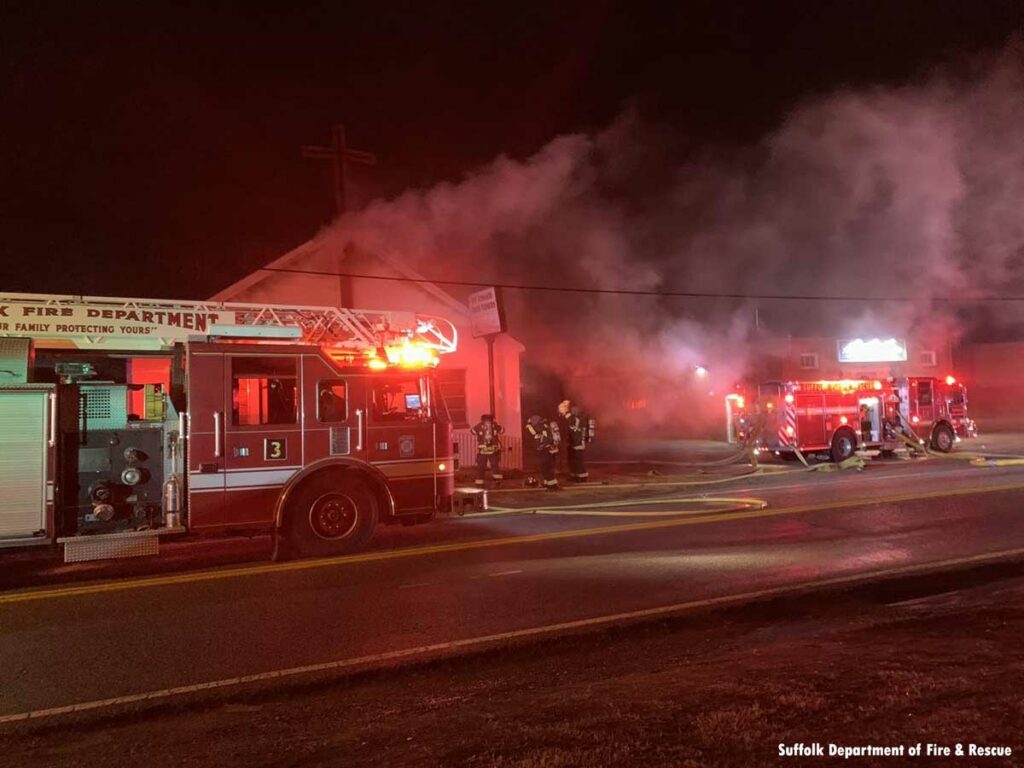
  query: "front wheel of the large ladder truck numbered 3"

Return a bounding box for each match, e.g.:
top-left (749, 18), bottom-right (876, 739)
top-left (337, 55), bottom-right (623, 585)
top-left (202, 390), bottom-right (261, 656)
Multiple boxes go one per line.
top-left (283, 471), bottom-right (378, 557)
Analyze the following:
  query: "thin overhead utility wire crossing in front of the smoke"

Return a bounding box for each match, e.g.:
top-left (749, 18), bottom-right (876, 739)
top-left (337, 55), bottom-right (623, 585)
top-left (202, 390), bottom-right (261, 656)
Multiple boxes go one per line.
top-left (260, 266), bottom-right (1024, 303)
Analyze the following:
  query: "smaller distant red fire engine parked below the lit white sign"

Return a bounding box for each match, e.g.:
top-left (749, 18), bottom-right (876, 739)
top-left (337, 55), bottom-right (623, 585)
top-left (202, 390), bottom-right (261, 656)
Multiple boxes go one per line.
top-left (726, 376), bottom-right (977, 462)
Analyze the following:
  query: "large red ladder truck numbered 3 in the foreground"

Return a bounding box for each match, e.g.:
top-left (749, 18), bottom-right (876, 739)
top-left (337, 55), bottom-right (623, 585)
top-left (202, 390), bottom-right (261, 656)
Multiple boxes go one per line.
top-left (0, 294), bottom-right (457, 560)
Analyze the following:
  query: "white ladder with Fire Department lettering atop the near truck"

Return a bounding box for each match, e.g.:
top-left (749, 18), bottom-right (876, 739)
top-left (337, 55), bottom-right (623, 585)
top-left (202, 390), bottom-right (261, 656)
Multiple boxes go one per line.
top-left (0, 293), bottom-right (458, 354)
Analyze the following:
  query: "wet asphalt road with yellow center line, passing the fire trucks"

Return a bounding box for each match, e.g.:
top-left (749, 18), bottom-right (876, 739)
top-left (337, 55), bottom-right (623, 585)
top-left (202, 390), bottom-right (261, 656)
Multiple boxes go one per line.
top-left (0, 460), bottom-right (1024, 720)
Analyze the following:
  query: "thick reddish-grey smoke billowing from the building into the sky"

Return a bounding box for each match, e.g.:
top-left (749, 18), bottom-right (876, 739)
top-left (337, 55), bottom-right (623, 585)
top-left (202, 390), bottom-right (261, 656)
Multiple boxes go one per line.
top-left (325, 43), bottom-right (1024, 436)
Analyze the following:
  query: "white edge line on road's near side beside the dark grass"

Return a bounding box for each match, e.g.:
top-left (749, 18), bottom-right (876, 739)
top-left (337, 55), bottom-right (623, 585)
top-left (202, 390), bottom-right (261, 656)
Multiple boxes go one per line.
top-left (0, 548), bottom-right (1024, 725)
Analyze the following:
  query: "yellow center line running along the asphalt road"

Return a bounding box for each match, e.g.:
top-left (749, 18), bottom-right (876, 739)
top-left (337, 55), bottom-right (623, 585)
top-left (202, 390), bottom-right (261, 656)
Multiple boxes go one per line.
top-left (6, 482), bottom-right (1024, 605)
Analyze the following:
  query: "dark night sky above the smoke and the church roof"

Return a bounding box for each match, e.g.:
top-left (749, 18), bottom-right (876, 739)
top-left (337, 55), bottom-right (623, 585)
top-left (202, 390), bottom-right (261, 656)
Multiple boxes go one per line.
top-left (0, 0), bottom-right (1024, 298)
